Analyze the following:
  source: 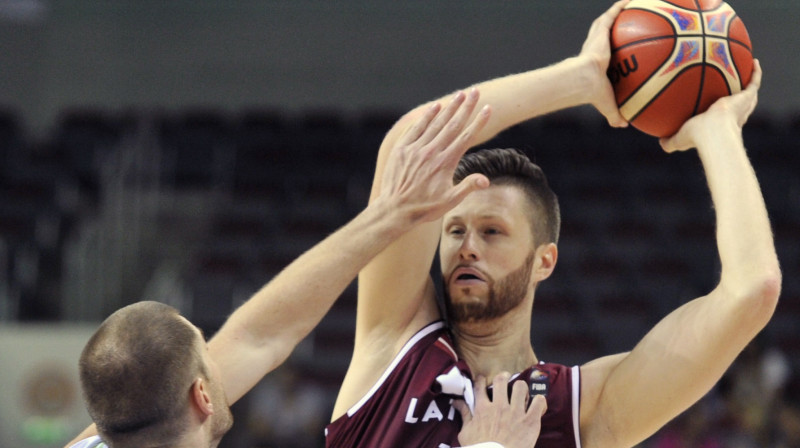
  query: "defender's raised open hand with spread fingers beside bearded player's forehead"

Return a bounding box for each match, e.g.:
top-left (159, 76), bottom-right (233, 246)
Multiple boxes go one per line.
top-left (380, 90), bottom-right (491, 223)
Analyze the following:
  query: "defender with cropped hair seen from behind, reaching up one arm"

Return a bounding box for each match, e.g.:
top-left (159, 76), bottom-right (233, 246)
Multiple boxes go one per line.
top-left (65, 89), bottom-right (546, 448)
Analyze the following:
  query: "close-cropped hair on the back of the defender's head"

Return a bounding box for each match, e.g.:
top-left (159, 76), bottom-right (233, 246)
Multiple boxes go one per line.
top-left (79, 301), bottom-right (208, 443)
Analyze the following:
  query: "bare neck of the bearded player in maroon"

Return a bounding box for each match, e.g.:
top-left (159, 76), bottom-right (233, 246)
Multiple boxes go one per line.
top-left (453, 310), bottom-right (538, 381)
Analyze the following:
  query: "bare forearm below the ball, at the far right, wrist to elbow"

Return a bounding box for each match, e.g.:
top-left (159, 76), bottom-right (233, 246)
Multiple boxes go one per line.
top-left (698, 120), bottom-right (780, 312)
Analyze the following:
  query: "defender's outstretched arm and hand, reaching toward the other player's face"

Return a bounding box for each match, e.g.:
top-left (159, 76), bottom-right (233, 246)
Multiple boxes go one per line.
top-left (209, 94), bottom-right (489, 403)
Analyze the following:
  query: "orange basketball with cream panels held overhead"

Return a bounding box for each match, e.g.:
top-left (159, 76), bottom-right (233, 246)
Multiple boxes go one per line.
top-left (608, 0), bottom-right (753, 137)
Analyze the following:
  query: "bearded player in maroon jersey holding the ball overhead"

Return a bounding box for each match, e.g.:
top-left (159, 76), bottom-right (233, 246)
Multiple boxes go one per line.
top-left (326, 2), bottom-right (781, 448)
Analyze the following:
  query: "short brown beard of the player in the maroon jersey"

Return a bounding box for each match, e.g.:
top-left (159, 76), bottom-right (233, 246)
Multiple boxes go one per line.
top-left (442, 251), bottom-right (536, 324)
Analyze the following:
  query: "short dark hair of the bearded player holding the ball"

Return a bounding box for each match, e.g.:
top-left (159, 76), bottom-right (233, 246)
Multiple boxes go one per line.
top-left (453, 148), bottom-right (561, 245)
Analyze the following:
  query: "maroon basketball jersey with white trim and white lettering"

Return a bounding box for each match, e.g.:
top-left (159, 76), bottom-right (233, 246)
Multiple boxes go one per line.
top-left (325, 322), bottom-right (580, 448)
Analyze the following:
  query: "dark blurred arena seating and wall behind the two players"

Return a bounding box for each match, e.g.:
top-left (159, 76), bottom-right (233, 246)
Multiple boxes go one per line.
top-left (0, 0), bottom-right (800, 448)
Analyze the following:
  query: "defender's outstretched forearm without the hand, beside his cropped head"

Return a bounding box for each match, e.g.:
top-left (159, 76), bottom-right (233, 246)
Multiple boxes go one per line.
top-left (209, 198), bottom-right (409, 403)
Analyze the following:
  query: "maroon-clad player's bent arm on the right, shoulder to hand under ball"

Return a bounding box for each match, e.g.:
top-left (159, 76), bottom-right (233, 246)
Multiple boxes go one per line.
top-left (581, 64), bottom-right (781, 448)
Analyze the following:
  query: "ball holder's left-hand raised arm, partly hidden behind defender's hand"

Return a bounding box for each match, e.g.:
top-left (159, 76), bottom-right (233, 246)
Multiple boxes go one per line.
top-left (345, 0), bottom-right (627, 395)
